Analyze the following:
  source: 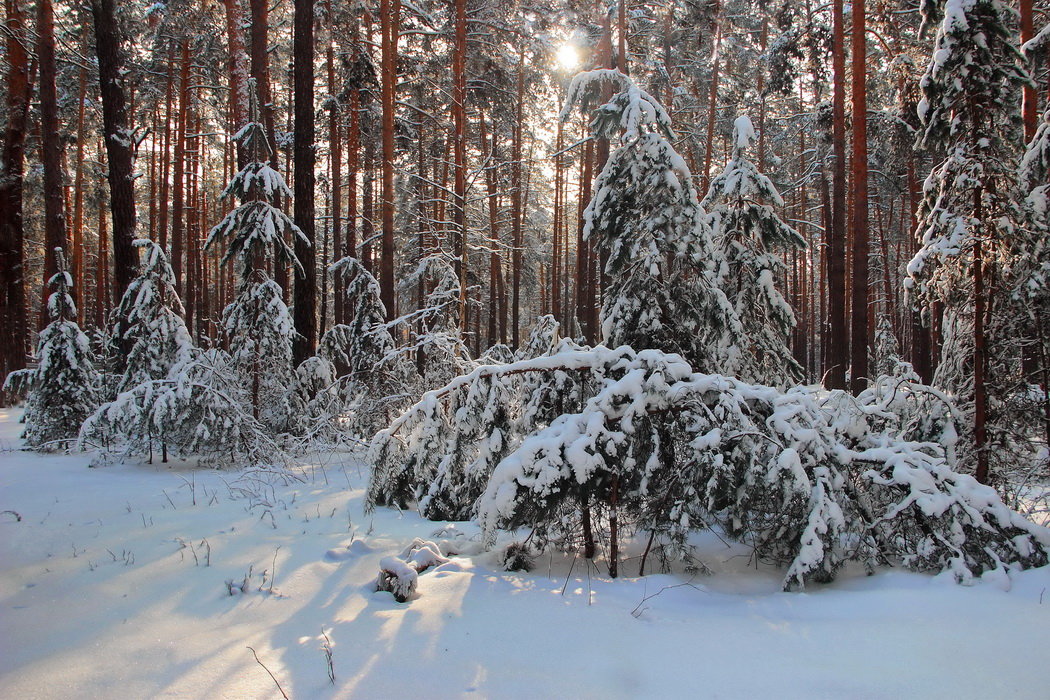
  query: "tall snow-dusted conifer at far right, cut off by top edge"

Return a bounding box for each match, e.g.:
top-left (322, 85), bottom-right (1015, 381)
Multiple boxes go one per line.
top-left (905, 0), bottom-right (1027, 481)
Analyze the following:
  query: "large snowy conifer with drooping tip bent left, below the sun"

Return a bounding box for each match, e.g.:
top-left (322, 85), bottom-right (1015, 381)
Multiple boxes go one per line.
top-left (562, 70), bottom-right (741, 374)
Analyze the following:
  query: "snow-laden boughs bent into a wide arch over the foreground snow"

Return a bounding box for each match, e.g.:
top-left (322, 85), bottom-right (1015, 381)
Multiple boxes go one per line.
top-left (369, 344), bottom-right (1050, 589)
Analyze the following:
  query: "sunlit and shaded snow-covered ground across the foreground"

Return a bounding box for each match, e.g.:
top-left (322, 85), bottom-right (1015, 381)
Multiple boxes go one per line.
top-left (0, 409), bottom-right (1050, 698)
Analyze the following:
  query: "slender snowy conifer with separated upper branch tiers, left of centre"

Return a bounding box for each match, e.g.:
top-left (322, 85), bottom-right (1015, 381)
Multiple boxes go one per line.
top-left (205, 87), bottom-right (306, 431)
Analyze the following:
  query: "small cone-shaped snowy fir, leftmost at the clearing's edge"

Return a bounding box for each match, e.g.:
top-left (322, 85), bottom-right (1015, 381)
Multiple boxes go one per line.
top-left (4, 248), bottom-right (100, 450)
